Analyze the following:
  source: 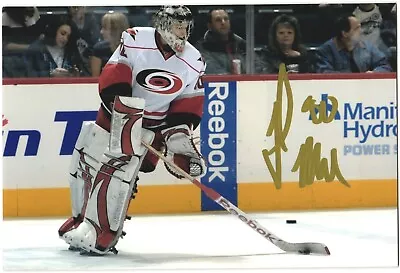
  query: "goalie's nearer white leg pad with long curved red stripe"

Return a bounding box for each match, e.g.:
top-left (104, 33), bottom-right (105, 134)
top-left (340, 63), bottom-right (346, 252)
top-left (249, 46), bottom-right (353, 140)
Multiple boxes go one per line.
top-left (72, 129), bottom-right (154, 254)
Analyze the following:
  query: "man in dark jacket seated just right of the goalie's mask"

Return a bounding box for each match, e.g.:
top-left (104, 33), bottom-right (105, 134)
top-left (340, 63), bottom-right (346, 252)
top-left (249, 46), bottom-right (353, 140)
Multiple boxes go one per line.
top-left (196, 9), bottom-right (246, 74)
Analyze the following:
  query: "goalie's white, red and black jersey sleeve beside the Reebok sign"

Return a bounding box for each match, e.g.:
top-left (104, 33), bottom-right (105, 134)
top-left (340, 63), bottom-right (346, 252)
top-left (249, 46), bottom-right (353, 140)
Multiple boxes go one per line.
top-left (167, 60), bottom-right (206, 128)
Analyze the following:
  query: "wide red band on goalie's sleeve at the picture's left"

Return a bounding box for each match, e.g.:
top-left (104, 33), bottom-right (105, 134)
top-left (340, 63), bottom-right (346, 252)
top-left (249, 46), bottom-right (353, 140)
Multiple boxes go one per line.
top-left (99, 63), bottom-right (132, 91)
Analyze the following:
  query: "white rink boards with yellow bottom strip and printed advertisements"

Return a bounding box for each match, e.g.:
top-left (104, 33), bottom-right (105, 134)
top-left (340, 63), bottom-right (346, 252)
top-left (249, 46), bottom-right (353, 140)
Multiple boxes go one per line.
top-left (3, 74), bottom-right (397, 217)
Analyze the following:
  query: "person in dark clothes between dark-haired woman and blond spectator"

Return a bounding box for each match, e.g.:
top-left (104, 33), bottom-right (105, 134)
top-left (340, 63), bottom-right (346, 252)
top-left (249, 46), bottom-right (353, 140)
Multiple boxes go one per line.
top-left (68, 6), bottom-right (100, 76)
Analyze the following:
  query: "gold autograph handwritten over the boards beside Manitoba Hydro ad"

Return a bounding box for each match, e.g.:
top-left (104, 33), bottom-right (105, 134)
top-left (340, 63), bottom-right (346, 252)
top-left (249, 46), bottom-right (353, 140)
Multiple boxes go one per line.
top-left (262, 64), bottom-right (350, 189)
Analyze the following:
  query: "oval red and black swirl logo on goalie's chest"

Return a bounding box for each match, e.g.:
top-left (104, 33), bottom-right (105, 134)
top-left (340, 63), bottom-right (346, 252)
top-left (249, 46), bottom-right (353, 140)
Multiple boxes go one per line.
top-left (136, 69), bottom-right (183, 94)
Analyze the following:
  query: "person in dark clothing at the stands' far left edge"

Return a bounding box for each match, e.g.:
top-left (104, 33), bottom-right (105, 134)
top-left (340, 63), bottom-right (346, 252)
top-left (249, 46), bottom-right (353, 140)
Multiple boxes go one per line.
top-left (2, 7), bottom-right (44, 77)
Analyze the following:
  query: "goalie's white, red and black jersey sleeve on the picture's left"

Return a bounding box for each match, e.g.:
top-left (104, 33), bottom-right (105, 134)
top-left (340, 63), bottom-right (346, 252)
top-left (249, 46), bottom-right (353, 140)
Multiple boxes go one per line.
top-left (99, 28), bottom-right (136, 113)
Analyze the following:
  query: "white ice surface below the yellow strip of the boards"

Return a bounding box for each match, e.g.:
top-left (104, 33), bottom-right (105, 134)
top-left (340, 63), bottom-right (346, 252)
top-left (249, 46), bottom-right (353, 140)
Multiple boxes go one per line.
top-left (2, 209), bottom-right (398, 271)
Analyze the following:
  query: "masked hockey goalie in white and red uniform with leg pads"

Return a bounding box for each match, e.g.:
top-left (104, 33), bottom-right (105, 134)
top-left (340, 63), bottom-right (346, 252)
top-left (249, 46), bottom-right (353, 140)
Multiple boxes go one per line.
top-left (58, 6), bottom-right (205, 255)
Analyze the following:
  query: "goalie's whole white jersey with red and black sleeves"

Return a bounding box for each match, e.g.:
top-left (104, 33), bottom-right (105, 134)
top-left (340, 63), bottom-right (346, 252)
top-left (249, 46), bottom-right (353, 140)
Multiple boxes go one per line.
top-left (96, 27), bottom-right (205, 130)
